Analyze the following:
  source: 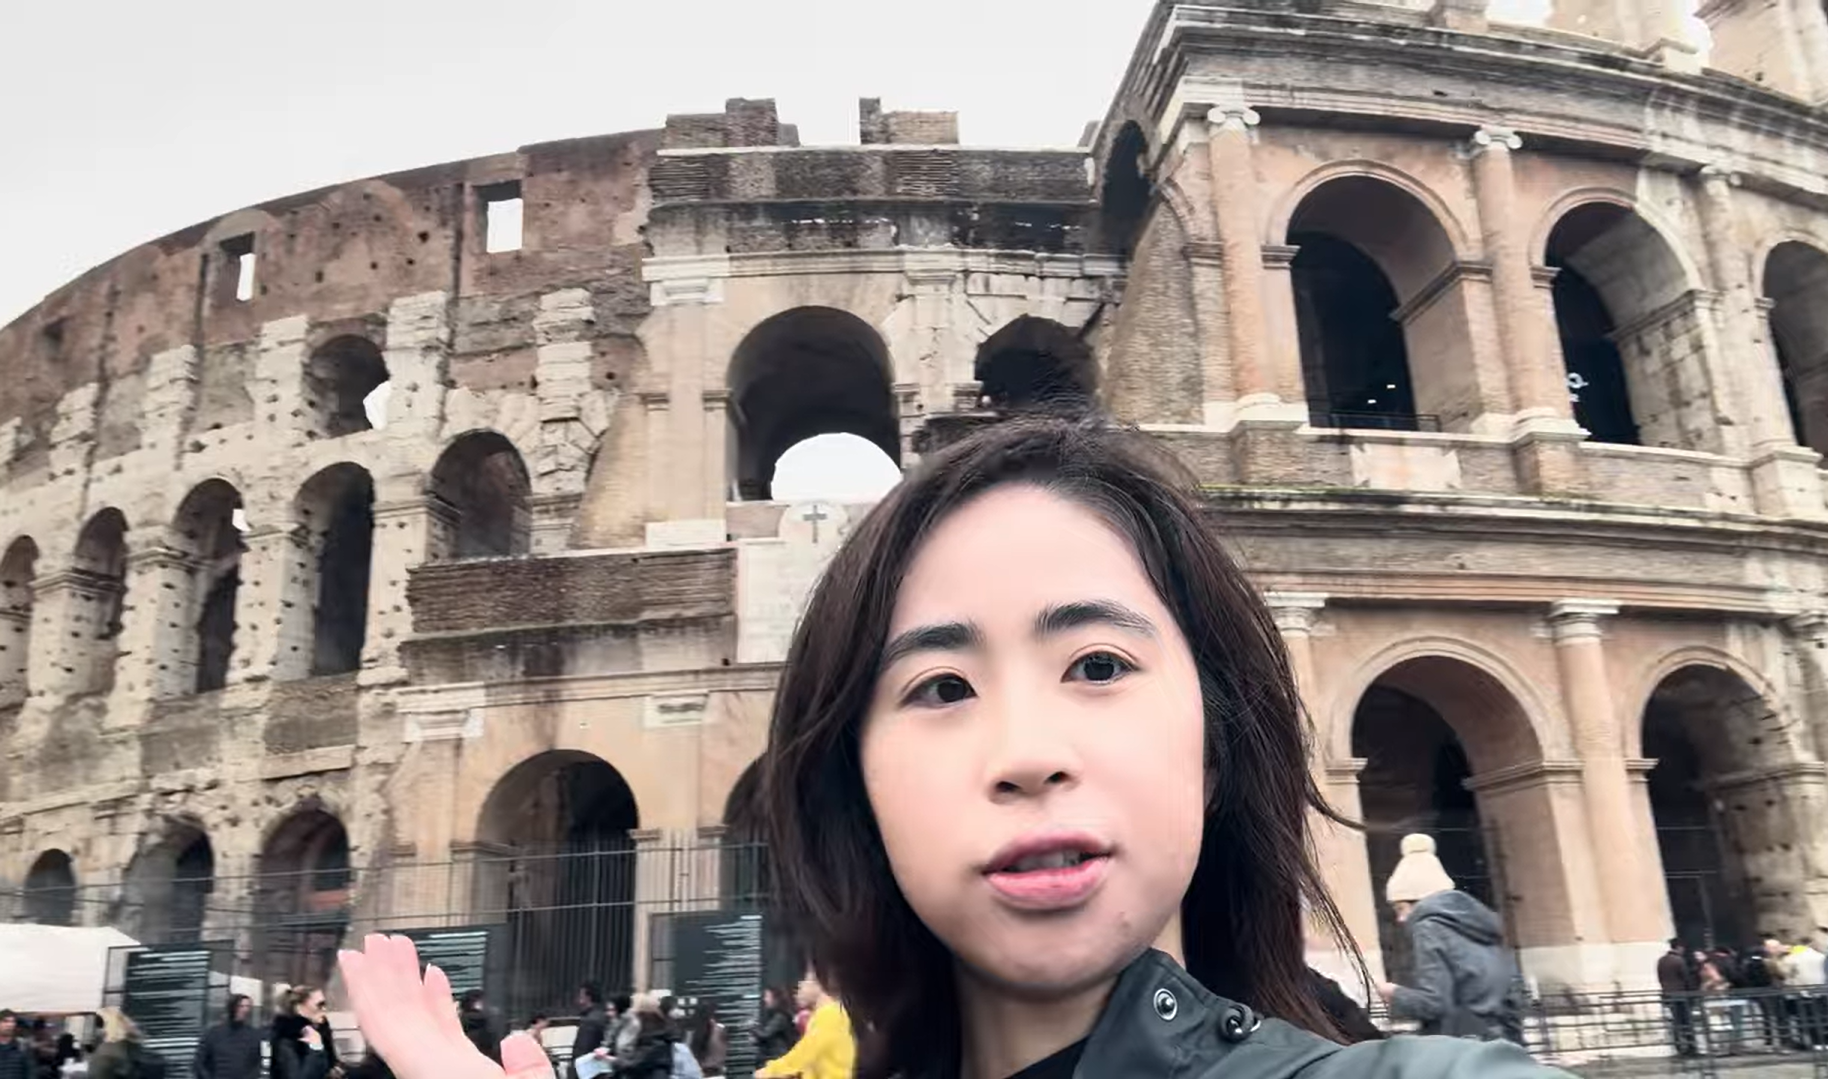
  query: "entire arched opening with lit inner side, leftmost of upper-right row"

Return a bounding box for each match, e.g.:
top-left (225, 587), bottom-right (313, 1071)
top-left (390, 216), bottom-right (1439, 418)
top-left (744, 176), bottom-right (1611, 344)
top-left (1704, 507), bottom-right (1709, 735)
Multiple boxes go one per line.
top-left (1287, 176), bottom-right (1479, 432)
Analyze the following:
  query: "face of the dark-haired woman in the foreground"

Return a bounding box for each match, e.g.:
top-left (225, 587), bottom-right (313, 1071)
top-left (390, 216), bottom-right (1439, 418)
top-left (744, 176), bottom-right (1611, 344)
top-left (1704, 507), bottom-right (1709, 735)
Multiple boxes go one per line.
top-left (863, 485), bottom-right (1205, 993)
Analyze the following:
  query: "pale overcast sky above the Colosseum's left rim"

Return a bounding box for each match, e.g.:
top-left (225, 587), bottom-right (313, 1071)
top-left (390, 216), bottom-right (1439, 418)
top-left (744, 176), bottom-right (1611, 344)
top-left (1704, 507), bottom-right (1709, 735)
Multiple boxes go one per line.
top-left (0, 0), bottom-right (1150, 324)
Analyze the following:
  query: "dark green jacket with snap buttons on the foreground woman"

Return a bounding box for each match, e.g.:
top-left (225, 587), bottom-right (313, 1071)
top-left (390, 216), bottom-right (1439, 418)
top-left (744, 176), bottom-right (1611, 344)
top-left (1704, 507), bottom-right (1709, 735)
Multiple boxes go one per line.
top-left (1052, 951), bottom-right (1568, 1079)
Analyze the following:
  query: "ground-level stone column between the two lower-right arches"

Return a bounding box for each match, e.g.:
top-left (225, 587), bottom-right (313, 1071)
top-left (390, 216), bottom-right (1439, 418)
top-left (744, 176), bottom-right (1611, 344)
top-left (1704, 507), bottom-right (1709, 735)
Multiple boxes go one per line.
top-left (1548, 600), bottom-right (1669, 982)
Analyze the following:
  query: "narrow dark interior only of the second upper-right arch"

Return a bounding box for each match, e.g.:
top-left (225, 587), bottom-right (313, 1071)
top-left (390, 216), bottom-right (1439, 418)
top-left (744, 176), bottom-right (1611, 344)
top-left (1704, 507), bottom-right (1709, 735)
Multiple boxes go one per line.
top-left (1545, 203), bottom-right (1642, 446)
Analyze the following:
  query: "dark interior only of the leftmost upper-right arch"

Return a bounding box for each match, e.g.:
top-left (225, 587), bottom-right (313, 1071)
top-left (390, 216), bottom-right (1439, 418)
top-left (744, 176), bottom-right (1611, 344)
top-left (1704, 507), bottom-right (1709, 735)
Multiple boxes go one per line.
top-left (1289, 232), bottom-right (1417, 432)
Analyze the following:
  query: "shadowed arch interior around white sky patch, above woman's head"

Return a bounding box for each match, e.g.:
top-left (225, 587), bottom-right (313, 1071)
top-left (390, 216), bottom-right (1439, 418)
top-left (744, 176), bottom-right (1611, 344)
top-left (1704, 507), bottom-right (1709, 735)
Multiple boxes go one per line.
top-left (729, 307), bottom-right (901, 501)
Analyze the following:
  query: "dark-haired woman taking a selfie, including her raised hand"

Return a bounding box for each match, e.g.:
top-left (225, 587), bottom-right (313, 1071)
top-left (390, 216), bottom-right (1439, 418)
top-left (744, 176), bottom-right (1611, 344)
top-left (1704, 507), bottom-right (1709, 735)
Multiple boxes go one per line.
top-left (344, 421), bottom-right (1554, 1079)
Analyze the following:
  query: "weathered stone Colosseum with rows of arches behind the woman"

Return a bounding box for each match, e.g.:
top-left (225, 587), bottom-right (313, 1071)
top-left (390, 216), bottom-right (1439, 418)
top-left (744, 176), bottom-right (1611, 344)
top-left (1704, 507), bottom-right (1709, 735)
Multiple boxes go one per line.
top-left (0, 0), bottom-right (1828, 1006)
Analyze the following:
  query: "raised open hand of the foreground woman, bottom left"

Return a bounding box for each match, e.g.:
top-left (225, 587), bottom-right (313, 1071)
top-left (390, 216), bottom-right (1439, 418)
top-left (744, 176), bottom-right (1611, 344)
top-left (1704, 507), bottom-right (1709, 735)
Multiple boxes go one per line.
top-left (340, 933), bottom-right (552, 1079)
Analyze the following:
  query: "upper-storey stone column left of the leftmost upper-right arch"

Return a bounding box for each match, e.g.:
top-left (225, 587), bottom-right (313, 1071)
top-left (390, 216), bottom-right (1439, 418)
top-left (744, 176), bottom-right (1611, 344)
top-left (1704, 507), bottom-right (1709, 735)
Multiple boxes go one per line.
top-left (1206, 97), bottom-right (1307, 426)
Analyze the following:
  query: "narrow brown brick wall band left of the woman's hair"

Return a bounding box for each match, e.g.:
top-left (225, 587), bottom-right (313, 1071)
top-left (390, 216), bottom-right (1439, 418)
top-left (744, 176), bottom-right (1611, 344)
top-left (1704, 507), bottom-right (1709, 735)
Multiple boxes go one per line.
top-left (406, 550), bottom-right (737, 633)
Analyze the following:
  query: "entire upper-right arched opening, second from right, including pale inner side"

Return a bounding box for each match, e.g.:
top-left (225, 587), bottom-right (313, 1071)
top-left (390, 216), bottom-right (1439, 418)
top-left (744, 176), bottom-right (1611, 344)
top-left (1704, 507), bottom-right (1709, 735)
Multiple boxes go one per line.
top-left (1545, 203), bottom-right (1716, 450)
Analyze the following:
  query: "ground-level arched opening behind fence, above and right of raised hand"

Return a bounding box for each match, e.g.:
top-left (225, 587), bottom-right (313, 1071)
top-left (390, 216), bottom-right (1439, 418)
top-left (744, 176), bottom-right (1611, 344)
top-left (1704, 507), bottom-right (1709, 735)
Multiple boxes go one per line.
top-left (477, 752), bottom-right (640, 1015)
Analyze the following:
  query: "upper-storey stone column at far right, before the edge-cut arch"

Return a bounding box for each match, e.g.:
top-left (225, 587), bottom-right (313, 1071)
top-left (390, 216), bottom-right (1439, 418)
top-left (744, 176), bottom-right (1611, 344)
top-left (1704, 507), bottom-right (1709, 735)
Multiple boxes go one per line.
top-left (1698, 165), bottom-right (1828, 519)
